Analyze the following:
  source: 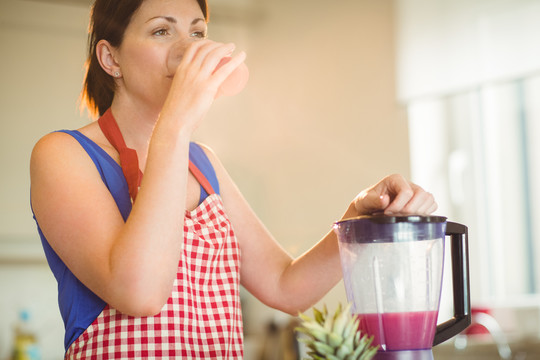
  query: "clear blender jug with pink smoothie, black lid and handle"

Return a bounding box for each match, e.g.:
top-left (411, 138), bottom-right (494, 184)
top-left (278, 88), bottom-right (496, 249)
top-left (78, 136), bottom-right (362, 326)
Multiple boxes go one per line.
top-left (334, 215), bottom-right (471, 360)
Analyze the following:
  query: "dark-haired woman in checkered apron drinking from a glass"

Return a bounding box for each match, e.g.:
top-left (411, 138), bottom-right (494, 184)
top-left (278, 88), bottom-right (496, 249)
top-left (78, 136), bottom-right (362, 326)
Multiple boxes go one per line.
top-left (31, 0), bottom-right (436, 358)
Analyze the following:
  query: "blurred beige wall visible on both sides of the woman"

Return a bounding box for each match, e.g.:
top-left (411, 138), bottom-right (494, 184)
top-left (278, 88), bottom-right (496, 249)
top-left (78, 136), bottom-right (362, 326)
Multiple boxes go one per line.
top-left (0, 0), bottom-right (409, 359)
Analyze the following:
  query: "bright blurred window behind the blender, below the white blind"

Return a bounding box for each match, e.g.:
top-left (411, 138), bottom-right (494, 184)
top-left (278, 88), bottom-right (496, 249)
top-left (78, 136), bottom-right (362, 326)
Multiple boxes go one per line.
top-left (408, 76), bottom-right (540, 307)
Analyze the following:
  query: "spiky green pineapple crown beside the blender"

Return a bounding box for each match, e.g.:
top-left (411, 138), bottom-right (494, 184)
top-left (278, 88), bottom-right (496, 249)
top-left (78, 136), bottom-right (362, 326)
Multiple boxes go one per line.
top-left (296, 304), bottom-right (378, 360)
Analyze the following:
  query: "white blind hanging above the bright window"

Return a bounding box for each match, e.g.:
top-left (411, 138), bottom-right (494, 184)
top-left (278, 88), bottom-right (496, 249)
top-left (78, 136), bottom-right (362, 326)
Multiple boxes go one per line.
top-left (396, 0), bottom-right (540, 101)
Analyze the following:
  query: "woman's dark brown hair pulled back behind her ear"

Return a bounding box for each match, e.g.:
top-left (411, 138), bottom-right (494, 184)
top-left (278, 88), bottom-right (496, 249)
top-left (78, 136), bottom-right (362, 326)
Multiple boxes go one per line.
top-left (81, 0), bottom-right (208, 117)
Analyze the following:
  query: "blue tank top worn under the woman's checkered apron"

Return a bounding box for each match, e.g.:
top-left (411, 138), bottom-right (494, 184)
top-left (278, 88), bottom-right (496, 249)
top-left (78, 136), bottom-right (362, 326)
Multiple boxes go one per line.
top-left (34, 130), bottom-right (219, 350)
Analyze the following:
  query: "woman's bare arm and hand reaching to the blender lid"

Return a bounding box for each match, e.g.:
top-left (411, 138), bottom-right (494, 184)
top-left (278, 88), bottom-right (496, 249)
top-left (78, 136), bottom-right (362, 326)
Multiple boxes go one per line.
top-left (210, 149), bottom-right (436, 315)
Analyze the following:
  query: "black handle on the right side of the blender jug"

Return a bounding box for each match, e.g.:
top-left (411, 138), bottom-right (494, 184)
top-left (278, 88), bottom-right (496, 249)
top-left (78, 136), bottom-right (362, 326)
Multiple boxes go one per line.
top-left (433, 221), bottom-right (471, 346)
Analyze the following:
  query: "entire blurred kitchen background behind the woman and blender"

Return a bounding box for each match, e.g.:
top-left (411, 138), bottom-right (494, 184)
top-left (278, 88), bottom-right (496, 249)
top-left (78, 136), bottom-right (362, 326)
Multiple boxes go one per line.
top-left (0, 0), bottom-right (540, 359)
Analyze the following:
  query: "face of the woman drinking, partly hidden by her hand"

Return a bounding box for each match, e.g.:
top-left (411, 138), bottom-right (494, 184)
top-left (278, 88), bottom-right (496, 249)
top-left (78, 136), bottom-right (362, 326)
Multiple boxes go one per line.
top-left (115, 0), bottom-right (207, 111)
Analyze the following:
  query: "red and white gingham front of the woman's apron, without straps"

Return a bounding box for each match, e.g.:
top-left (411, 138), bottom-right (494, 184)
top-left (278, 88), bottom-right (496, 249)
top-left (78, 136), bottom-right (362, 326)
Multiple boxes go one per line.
top-left (66, 194), bottom-right (243, 359)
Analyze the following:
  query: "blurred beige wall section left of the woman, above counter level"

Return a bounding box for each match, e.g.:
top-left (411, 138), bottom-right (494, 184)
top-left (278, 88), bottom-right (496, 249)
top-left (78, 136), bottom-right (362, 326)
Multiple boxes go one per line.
top-left (0, 0), bottom-right (88, 242)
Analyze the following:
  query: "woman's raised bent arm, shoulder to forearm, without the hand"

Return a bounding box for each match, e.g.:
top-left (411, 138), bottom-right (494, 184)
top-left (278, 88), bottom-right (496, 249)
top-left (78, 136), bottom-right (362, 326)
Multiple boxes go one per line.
top-left (31, 126), bottom-right (192, 315)
